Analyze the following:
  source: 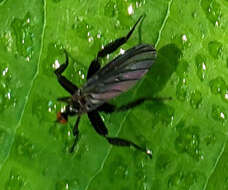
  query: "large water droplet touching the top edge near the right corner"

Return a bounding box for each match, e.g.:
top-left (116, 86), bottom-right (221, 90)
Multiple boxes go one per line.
top-left (201, 0), bottom-right (222, 27)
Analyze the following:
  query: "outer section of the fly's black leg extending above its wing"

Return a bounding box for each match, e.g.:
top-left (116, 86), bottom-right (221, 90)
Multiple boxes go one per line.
top-left (97, 15), bottom-right (144, 57)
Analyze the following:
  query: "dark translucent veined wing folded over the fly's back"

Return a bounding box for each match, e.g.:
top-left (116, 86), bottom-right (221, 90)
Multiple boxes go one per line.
top-left (82, 44), bottom-right (156, 109)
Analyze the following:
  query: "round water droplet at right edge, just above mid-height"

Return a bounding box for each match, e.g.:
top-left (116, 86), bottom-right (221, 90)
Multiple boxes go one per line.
top-left (209, 77), bottom-right (226, 94)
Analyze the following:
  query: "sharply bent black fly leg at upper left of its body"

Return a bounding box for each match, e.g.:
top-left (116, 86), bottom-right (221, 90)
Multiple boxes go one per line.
top-left (55, 51), bottom-right (78, 94)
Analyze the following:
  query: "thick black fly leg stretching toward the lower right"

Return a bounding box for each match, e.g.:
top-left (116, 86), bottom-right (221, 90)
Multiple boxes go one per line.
top-left (88, 111), bottom-right (151, 157)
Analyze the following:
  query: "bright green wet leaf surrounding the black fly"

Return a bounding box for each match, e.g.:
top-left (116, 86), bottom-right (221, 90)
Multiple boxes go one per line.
top-left (0, 0), bottom-right (228, 190)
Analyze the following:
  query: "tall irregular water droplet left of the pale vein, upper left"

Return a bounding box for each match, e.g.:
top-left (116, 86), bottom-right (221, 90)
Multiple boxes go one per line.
top-left (11, 13), bottom-right (34, 61)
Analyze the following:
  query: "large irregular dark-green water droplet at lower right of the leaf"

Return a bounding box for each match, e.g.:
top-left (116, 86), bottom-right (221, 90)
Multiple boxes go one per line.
top-left (175, 126), bottom-right (201, 161)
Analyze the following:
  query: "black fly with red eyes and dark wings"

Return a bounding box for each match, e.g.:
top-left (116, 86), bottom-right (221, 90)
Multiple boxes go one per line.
top-left (55, 16), bottom-right (156, 156)
